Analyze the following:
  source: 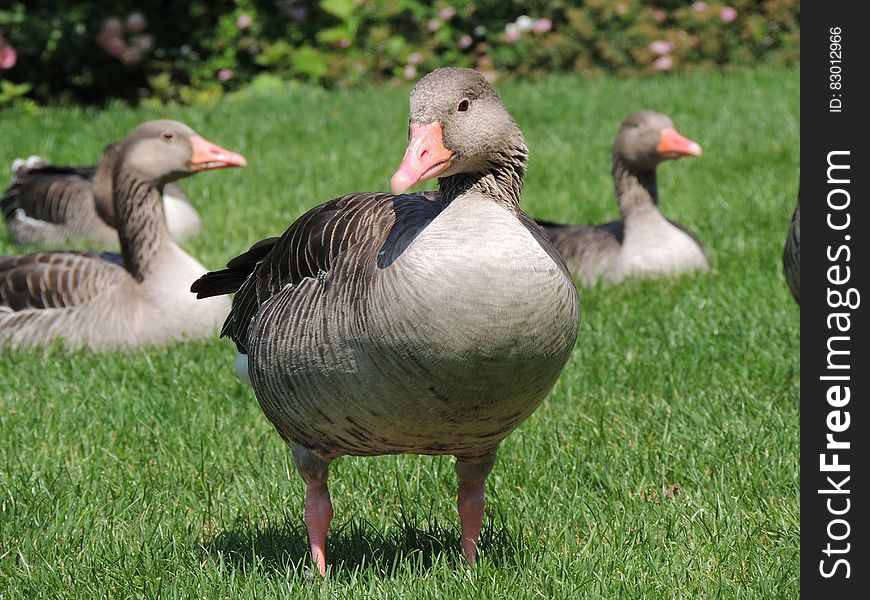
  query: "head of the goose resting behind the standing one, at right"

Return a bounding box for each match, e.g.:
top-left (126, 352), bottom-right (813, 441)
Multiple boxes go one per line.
top-left (613, 110), bottom-right (701, 171)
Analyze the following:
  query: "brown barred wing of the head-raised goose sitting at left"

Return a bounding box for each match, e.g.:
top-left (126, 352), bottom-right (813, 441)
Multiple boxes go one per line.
top-left (0, 252), bottom-right (126, 311)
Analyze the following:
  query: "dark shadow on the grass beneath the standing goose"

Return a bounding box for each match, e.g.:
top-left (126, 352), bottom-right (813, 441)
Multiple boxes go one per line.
top-left (201, 510), bottom-right (533, 578)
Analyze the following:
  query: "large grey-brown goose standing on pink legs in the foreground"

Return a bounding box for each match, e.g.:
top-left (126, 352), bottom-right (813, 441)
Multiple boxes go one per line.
top-left (192, 68), bottom-right (579, 575)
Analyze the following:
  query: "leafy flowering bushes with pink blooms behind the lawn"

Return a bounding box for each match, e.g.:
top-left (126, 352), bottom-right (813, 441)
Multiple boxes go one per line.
top-left (0, 0), bottom-right (800, 102)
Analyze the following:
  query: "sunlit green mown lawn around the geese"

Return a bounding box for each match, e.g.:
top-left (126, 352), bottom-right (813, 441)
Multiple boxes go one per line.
top-left (0, 68), bottom-right (800, 600)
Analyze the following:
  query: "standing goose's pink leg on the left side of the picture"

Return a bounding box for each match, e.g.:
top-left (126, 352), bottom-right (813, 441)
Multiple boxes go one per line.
top-left (293, 444), bottom-right (333, 576)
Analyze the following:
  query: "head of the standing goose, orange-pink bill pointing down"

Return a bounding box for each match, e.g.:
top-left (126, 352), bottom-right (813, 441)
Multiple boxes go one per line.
top-left (390, 68), bottom-right (525, 194)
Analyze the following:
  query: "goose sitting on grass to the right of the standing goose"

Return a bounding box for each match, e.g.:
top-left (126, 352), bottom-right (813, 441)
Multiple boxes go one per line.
top-left (538, 110), bottom-right (709, 287)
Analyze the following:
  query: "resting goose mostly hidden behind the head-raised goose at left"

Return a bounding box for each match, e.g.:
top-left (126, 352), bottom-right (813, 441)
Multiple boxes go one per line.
top-left (0, 143), bottom-right (202, 248)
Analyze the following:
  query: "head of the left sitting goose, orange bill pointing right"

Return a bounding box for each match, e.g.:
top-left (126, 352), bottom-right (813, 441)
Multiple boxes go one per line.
top-left (118, 119), bottom-right (247, 186)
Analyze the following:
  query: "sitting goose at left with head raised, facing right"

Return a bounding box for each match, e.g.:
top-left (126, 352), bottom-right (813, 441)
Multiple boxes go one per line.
top-left (0, 120), bottom-right (245, 351)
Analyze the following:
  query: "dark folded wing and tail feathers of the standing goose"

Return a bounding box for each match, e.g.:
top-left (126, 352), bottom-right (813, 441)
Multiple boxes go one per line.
top-left (191, 193), bottom-right (443, 351)
